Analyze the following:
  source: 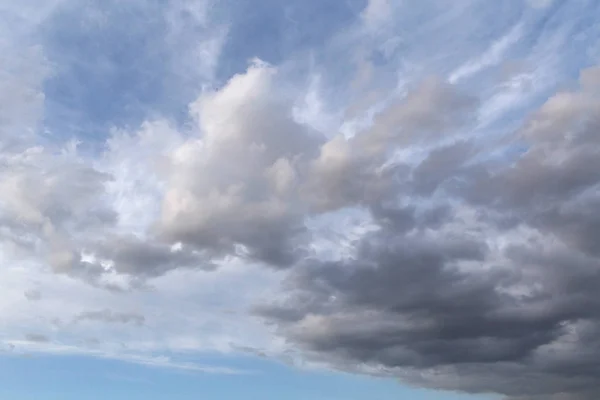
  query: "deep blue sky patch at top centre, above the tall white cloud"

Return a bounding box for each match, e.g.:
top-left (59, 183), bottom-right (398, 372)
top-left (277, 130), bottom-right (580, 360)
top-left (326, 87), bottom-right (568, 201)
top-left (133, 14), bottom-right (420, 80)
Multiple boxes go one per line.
top-left (218, 0), bottom-right (367, 80)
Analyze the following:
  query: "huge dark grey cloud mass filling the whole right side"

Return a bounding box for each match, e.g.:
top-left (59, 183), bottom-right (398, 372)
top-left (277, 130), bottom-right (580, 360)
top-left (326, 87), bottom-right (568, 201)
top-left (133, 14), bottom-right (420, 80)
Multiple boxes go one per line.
top-left (255, 64), bottom-right (600, 400)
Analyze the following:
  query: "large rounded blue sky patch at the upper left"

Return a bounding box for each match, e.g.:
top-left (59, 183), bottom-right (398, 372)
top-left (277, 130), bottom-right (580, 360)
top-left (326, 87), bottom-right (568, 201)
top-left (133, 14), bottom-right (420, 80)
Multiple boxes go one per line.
top-left (39, 0), bottom-right (220, 141)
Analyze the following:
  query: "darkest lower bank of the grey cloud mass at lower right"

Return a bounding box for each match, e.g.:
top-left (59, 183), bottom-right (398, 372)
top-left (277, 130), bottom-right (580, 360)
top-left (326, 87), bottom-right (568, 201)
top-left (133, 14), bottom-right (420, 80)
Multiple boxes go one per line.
top-left (258, 220), bottom-right (600, 396)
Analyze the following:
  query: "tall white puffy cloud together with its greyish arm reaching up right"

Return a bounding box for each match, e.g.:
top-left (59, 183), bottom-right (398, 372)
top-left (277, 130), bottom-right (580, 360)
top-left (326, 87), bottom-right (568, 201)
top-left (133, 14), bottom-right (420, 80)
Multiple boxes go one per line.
top-left (159, 63), bottom-right (474, 267)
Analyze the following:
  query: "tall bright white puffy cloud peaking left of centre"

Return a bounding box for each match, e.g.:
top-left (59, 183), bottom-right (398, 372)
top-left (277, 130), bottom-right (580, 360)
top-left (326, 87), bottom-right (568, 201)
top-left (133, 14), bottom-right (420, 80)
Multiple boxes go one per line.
top-left (160, 64), bottom-right (319, 266)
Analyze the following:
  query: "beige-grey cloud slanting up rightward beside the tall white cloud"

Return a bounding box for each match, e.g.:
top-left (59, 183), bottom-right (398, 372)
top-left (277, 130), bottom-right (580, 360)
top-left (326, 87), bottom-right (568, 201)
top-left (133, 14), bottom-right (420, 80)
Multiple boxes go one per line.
top-left (305, 78), bottom-right (477, 213)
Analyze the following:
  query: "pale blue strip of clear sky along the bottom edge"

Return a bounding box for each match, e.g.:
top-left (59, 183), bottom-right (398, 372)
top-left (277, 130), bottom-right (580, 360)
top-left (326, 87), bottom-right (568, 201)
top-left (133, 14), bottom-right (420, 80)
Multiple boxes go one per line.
top-left (0, 356), bottom-right (497, 400)
